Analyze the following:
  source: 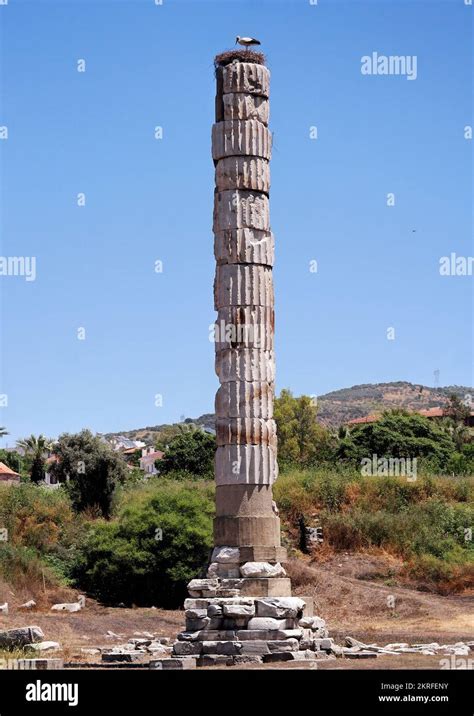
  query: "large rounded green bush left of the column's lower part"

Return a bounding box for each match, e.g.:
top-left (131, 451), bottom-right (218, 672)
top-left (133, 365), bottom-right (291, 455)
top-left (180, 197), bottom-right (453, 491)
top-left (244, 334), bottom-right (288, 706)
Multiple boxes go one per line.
top-left (73, 480), bottom-right (214, 608)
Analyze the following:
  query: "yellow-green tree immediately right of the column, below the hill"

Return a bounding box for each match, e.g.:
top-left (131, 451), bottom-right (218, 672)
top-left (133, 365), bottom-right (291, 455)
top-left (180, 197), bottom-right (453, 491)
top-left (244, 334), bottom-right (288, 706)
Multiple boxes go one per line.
top-left (274, 388), bottom-right (333, 465)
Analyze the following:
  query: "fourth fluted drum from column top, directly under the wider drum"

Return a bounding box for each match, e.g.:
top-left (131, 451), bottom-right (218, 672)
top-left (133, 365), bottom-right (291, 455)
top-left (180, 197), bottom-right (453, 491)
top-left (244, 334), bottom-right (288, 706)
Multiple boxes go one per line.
top-left (216, 156), bottom-right (270, 194)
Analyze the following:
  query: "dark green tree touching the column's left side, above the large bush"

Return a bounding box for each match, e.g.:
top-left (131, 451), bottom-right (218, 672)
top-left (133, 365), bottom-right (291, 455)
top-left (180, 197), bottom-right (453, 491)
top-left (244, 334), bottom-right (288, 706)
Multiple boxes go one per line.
top-left (156, 430), bottom-right (216, 477)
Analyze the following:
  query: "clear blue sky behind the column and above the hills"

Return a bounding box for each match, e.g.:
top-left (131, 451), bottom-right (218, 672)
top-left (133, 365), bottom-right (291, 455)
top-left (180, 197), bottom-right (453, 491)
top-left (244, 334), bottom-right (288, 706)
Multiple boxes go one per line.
top-left (0, 0), bottom-right (474, 444)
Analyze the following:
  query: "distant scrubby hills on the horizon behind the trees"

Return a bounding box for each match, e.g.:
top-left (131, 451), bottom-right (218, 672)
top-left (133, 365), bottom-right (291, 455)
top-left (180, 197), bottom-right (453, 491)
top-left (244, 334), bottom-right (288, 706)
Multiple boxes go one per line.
top-left (104, 381), bottom-right (474, 443)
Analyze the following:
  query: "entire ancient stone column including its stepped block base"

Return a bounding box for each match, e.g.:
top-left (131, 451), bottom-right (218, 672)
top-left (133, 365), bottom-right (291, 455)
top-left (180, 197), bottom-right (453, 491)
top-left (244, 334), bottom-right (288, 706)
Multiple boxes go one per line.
top-left (166, 52), bottom-right (327, 666)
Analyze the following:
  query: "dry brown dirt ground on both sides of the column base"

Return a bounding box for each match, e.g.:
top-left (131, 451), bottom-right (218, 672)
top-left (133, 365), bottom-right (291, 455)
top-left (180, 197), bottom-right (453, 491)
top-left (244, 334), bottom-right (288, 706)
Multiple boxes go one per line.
top-left (0, 554), bottom-right (474, 669)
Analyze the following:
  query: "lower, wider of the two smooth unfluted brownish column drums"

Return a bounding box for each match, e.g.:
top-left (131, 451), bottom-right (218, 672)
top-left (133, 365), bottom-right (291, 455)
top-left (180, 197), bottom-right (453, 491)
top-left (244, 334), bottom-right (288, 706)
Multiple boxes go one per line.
top-left (214, 516), bottom-right (282, 548)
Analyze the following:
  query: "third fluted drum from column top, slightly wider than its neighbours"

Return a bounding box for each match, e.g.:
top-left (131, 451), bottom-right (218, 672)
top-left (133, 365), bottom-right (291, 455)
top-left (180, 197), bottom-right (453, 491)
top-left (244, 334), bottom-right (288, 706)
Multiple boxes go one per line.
top-left (212, 119), bottom-right (272, 161)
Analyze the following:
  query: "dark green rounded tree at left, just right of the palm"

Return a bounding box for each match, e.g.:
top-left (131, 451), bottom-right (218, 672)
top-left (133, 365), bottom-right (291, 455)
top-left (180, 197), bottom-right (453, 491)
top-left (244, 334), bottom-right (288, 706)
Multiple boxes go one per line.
top-left (51, 430), bottom-right (127, 518)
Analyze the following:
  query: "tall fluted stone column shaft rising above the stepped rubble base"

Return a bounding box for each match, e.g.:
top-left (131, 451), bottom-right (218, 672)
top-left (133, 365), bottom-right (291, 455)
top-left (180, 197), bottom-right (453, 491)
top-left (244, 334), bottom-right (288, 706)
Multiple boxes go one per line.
top-left (208, 60), bottom-right (291, 596)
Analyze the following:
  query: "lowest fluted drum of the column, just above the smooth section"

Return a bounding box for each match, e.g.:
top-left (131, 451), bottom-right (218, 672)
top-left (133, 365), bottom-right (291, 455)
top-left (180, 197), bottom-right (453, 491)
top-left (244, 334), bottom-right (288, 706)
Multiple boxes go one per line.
top-left (215, 445), bottom-right (278, 486)
